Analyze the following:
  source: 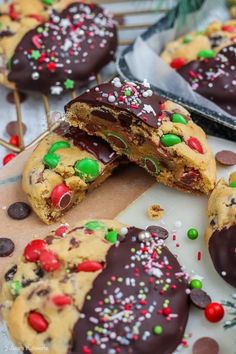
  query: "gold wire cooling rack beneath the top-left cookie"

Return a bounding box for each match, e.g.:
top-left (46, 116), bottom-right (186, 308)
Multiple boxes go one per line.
top-left (0, 0), bottom-right (174, 160)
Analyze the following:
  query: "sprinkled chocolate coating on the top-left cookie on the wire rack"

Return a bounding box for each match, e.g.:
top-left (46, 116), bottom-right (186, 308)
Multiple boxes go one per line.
top-left (8, 2), bottom-right (117, 95)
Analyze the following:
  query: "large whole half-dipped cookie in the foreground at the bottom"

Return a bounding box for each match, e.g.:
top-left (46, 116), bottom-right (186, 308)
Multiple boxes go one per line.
top-left (1, 220), bottom-right (189, 354)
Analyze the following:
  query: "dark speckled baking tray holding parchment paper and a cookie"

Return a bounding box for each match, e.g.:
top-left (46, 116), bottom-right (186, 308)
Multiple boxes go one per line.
top-left (117, 0), bottom-right (236, 141)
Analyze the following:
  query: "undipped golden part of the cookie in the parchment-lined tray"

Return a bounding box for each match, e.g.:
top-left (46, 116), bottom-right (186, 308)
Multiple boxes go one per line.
top-left (161, 20), bottom-right (236, 69)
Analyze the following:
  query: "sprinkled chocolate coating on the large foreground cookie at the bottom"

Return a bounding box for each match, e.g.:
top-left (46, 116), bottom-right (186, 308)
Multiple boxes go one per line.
top-left (69, 227), bottom-right (189, 354)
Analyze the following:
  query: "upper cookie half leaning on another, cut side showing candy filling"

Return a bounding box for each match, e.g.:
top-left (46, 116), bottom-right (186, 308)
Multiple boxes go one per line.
top-left (65, 78), bottom-right (215, 193)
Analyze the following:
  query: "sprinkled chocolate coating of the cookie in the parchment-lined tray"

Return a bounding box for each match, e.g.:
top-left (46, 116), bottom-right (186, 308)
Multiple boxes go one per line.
top-left (178, 44), bottom-right (236, 115)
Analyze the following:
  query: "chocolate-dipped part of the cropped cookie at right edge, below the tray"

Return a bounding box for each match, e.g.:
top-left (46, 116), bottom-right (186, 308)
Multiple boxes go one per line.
top-left (208, 225), bottom-right (236, 287)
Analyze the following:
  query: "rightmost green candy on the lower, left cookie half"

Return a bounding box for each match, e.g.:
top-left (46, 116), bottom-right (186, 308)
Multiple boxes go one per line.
top-left (75, 157), bottom-right (99, 182)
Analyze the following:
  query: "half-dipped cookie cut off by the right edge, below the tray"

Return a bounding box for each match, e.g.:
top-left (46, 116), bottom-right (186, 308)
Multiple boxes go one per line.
top-left (206, 172), bottom-right (236, 287)
